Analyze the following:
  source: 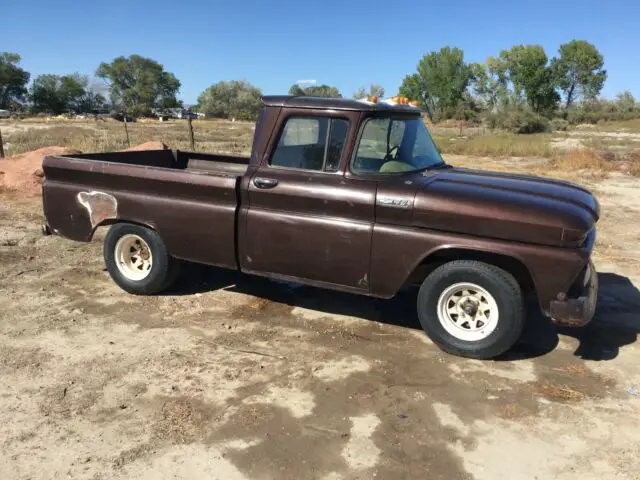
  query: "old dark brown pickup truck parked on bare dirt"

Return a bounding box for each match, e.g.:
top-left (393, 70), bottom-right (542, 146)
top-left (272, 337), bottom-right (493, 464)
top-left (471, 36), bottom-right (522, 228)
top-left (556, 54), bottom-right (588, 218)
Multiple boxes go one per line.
top-left (43, 96), bottom-right (599, 358)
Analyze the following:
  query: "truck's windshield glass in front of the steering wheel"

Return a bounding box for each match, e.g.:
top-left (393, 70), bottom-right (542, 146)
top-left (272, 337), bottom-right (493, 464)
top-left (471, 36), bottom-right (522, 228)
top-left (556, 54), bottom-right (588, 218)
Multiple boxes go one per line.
top-left (351, 118), bottom-right (444, 173)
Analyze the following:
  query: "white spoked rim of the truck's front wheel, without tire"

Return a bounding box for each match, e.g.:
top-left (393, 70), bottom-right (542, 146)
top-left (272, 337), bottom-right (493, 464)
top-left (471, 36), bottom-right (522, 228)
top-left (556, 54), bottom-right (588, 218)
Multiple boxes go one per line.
top-left (438, 283), bottom-right (499, 342)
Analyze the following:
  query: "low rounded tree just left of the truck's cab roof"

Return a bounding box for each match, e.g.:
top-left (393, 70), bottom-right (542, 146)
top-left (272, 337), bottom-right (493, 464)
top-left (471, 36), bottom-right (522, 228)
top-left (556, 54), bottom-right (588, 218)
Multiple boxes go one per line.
top-left (198, 80), bottom-right (262, 120)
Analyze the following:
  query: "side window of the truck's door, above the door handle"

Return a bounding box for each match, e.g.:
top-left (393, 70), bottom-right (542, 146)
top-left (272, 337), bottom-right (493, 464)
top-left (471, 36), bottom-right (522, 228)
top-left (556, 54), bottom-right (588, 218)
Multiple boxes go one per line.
top-left (271, 117), bottom-right (349, 172)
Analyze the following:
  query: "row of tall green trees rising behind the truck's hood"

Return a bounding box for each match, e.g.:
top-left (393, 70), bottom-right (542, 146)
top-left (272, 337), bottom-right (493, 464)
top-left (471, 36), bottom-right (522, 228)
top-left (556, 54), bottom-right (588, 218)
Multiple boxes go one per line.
top-left (400, 40), bottom-right (607, 130)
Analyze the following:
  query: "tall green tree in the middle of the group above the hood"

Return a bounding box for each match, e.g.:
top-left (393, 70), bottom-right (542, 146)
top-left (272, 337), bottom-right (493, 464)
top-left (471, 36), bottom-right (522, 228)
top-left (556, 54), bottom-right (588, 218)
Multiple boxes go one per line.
top-left (500, 45), bottom-right (560, 115)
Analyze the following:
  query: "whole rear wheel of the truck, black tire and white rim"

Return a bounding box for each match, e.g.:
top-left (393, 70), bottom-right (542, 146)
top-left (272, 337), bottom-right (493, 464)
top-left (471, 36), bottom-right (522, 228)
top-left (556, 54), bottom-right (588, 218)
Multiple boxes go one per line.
top-left (104, 223), bottom-right (179, 295)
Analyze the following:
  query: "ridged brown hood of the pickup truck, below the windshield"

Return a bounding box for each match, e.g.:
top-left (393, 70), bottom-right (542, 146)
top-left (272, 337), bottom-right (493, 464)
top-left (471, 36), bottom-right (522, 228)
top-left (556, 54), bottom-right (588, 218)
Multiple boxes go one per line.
top-left (412, 168), bottom-right (600, 246)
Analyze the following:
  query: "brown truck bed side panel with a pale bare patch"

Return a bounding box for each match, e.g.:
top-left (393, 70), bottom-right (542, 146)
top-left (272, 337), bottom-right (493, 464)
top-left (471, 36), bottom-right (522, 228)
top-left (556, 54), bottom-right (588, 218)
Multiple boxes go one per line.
top-left (43, 157), bottom-right (238, 268)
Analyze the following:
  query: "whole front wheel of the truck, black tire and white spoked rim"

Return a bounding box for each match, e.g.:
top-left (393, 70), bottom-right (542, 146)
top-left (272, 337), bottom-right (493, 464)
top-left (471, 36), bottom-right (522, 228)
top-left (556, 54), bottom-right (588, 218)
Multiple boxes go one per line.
top-left (418, 260), bottom-right (525, 359)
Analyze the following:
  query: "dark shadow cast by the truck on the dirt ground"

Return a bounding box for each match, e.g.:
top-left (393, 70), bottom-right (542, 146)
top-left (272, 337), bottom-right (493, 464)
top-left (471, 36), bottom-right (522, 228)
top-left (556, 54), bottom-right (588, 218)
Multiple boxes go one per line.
top-left (167, 264), bottom-right (640, 361)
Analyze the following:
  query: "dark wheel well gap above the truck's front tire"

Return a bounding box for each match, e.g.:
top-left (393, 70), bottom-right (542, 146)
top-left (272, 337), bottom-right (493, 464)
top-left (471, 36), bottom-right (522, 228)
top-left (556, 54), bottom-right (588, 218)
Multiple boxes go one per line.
top-left (406, 248), bottom-right (536, 295)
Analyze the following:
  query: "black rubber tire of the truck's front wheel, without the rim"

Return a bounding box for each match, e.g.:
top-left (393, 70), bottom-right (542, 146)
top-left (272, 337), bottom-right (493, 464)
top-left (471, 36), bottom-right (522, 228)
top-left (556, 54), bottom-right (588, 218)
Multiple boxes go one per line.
top-left (418, 260), bottom-right (526, 359)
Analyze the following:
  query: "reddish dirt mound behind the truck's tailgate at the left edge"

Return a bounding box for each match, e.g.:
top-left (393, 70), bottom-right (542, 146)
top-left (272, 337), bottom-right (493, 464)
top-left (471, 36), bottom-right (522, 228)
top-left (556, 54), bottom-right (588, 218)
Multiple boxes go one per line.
top-left (0, 147), bottom-right (80, 195)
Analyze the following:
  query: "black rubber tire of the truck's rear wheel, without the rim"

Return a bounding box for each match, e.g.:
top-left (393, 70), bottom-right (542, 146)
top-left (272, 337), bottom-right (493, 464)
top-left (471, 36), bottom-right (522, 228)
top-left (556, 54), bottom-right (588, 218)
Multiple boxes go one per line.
top-left (104, 223), bottom-right (180, 295)
